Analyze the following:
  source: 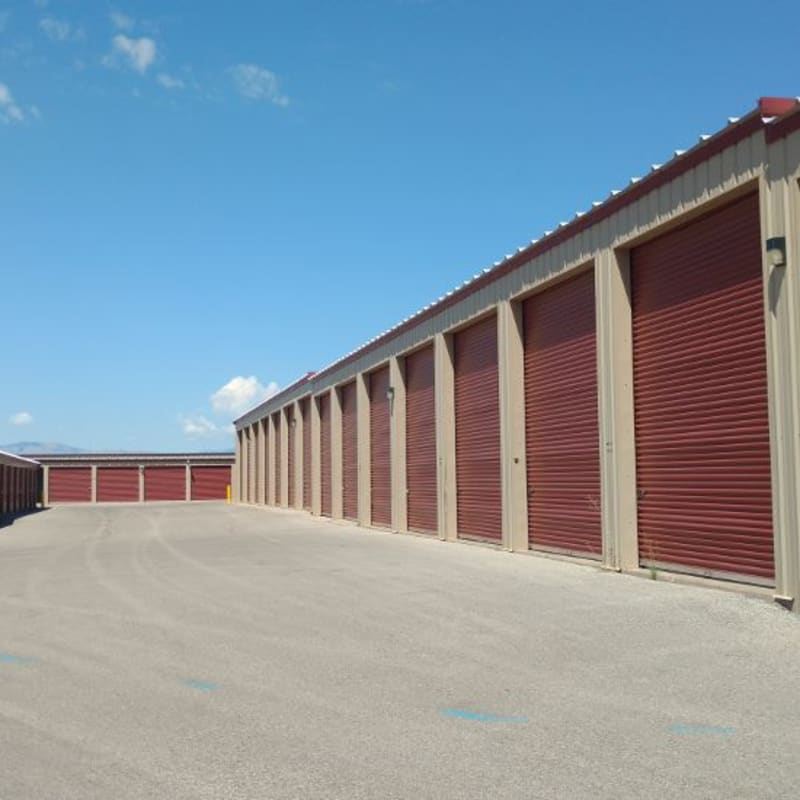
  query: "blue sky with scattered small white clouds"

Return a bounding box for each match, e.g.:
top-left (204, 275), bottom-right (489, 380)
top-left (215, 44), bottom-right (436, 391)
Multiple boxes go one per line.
top-left (0, 0), bottom-right (800, 450)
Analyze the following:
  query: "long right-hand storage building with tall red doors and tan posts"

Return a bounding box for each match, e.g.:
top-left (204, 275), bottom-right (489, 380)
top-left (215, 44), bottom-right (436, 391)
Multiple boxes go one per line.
top-left (234, 99), bottom-right (800, 604)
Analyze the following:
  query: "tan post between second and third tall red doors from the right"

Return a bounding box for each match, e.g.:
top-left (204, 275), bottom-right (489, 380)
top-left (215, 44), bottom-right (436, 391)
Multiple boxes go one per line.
top-left (497, 300), bottom-right (528, 550)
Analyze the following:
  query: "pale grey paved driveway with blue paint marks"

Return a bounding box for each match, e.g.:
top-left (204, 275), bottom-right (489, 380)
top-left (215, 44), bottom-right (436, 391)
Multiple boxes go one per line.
top-left (0, 504), bottom-right (800, 800)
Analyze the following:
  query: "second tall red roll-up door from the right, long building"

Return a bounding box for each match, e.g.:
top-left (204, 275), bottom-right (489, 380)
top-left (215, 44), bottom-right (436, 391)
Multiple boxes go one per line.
top-left (523, 271), bottom-right (603, 556)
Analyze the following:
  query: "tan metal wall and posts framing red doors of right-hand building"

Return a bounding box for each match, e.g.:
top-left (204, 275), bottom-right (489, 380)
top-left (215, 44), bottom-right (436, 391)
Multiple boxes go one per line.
top-left (237, 117), bottom-right (800, 604)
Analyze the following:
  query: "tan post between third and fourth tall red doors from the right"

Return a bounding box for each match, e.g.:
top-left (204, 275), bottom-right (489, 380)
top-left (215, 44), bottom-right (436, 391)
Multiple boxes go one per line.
top-left (433, 333), bottom-right (458, 542)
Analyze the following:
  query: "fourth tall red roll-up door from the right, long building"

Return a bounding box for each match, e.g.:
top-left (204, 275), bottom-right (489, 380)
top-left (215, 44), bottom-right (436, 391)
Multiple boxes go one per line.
top-left (405, 346), bottom-right (439, 533)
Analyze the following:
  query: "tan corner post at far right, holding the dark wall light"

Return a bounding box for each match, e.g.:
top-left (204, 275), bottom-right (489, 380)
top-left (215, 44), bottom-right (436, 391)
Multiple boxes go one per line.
top-left (759, 139), bottom-right (800, 613)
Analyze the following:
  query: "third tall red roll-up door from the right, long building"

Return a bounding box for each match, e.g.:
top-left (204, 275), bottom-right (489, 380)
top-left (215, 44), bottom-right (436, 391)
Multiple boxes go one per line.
top-left (454, 315), bottom-right (502, 540)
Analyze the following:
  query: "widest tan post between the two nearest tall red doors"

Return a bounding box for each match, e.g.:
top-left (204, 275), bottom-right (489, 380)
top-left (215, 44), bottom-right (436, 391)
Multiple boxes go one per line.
top-left (594, 248), bottom-right (639, 571)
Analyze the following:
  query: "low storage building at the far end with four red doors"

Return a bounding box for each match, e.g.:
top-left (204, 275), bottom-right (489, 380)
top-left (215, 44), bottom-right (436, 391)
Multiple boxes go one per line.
top-left (36, 453), bottom-right (233, 505)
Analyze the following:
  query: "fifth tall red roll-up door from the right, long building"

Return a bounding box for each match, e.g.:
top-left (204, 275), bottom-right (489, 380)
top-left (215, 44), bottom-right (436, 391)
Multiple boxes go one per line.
top-left (369, 366), bottom-right (392, 526)
